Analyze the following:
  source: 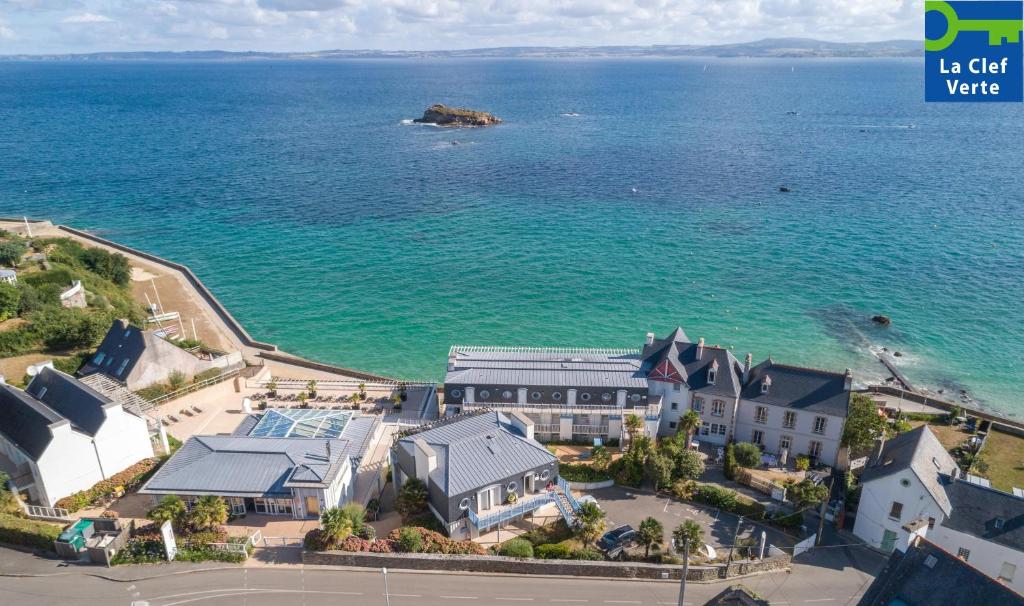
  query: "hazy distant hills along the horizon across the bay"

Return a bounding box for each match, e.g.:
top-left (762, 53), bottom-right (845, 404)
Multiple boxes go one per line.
top-left (0, 38), bottom-right (924, 61)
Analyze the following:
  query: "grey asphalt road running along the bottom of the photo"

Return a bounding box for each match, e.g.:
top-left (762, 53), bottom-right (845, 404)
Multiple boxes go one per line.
top-left (0, 564), bottom-right (871, 606)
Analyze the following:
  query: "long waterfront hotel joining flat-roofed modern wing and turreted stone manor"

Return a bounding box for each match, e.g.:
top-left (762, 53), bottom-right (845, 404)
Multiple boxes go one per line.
top-left (444, 328), bottom-right (853, 466)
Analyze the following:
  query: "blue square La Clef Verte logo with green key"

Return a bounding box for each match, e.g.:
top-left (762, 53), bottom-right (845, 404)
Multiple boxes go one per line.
top-left (925, 0), bottom-right (1024, 102)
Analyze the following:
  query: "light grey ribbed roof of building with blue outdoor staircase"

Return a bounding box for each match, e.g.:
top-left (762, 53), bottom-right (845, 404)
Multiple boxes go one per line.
top-left (398, 410), bottom-right (557, 496)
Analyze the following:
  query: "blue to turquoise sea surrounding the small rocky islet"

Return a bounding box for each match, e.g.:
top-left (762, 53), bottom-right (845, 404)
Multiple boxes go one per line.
top-left (0, 59), bottom-right (1024, 414)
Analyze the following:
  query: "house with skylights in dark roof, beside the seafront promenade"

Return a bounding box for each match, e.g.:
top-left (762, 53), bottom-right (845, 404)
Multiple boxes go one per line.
top-left (78, 319), bottom-right (245, 391)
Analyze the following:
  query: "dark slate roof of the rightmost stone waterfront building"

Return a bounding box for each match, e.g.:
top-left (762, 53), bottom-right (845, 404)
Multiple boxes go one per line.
top-left (740, 358), bottom-right (851, 417)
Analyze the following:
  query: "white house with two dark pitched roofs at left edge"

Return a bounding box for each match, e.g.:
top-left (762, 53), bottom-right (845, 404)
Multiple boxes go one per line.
top-left (0, 366), bottom-right (153, 507)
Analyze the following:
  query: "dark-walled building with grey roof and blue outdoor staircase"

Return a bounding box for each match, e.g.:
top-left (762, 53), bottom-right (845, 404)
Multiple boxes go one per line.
top-left (391, 410), bottom-right (558, 536)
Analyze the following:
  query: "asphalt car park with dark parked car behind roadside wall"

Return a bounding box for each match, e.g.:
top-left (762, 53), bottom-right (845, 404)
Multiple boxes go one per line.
top-left (588, 486), bottom-right (798, 550)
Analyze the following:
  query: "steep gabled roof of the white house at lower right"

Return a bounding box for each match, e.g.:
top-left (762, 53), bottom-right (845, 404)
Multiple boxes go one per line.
top-left (860, 425), bottom-right (956, 516)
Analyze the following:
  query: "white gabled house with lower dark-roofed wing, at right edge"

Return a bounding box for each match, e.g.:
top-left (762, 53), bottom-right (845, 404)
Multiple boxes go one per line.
top-left (853, 426), bottom-right (1024, 593)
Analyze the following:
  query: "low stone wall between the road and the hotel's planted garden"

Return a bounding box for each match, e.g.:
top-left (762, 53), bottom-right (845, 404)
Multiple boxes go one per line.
top-left (302, 551), bottom-right (791, 582)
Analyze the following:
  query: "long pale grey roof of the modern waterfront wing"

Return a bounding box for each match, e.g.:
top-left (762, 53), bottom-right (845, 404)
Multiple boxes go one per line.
top-left (444, 345), bottom-right (647, 389)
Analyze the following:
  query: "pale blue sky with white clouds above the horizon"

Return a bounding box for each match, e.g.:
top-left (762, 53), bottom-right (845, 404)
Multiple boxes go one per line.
top-left (0, 0), bottom-right (924, 55)
